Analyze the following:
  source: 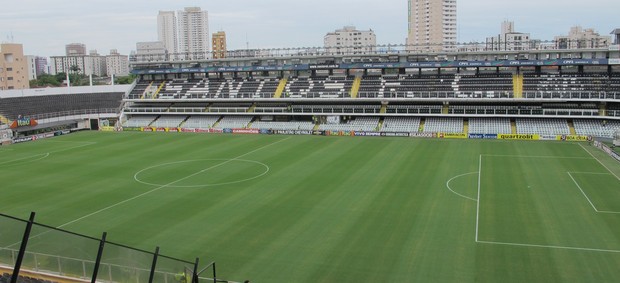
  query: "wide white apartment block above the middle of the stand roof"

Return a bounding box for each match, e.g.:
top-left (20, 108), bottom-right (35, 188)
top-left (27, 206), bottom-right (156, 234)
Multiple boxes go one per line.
top-left (323, 26), bottom-right (377, 54)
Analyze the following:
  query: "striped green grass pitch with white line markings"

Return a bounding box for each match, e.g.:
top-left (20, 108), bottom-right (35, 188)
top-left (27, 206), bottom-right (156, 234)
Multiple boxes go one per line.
top-left (0, 132), bottom-right (620, 282)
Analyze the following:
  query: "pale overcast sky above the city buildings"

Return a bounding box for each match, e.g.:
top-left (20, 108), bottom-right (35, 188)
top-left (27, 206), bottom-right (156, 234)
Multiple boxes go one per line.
top-left (0, 0), bottom-right (620, 56)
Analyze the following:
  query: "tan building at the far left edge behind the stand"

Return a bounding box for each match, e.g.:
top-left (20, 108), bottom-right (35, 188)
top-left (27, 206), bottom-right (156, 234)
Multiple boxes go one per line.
top-left (0, 43), bottom-right (30, 90)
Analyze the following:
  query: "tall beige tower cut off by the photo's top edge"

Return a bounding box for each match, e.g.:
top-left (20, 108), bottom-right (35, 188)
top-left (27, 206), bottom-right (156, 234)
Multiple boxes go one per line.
top-left (407, 0), bottom-right (457, 52)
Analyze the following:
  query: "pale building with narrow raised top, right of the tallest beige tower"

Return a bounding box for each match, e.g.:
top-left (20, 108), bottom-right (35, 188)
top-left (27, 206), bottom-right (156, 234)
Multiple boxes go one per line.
top-left (485, 21), bottom-right (533, 51)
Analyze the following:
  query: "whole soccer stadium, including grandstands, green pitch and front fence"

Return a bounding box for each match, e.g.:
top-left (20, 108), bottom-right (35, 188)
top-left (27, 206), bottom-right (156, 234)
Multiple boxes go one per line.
top-left (0, 26), bottom-right (620, 282)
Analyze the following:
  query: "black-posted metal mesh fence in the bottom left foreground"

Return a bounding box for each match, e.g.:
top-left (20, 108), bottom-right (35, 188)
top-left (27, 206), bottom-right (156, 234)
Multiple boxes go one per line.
top-left (0, 212), bottom-right (228, 283)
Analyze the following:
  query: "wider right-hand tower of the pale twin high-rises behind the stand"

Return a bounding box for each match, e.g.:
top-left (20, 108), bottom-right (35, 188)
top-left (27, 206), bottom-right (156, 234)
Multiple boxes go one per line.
top-left (177, 7), bottom-right (210, 59)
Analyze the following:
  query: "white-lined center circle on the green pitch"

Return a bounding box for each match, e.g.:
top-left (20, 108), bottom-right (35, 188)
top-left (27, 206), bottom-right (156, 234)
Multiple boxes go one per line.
top-left (134, 159), bottom-right (269, 188)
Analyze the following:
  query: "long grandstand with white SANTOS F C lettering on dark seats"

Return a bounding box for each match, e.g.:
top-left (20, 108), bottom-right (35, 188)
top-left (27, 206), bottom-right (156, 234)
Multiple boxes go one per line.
top-left (0, 45), bottom-right (620, 148)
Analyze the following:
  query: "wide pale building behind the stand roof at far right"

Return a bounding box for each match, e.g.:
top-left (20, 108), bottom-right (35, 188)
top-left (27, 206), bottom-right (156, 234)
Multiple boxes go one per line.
top-left (554, 26), bottom-right (611, 49)
